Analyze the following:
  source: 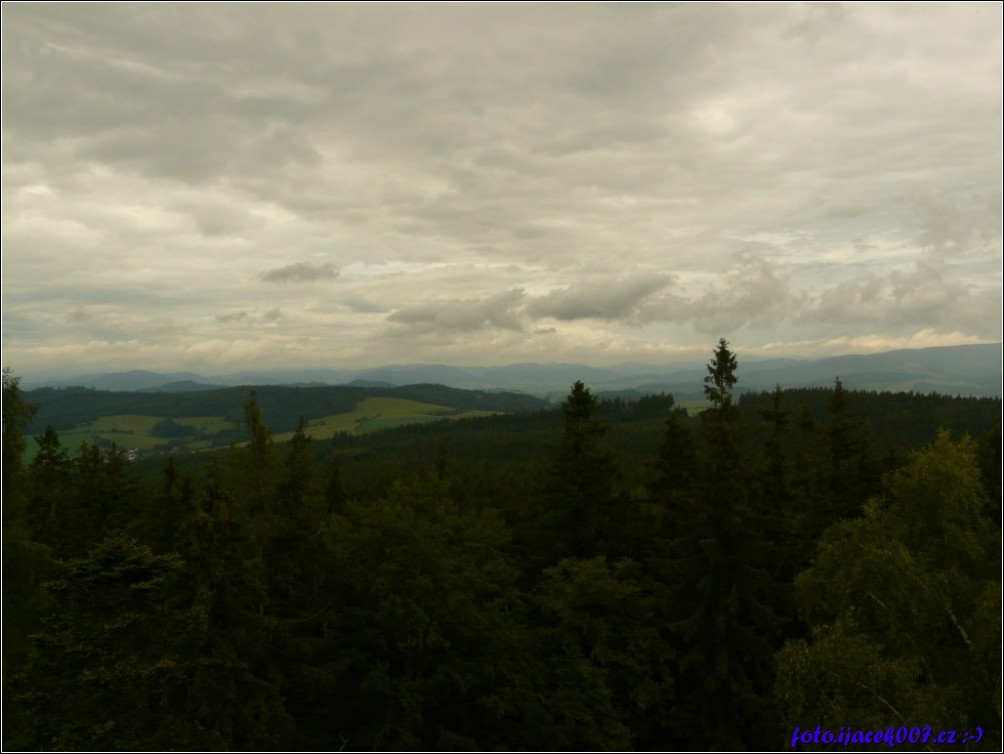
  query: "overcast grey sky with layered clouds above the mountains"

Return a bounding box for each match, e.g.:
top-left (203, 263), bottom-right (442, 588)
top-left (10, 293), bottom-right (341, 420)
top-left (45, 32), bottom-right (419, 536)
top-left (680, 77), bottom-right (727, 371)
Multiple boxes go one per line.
top-left (0, 2), bottom-right (1004, 376)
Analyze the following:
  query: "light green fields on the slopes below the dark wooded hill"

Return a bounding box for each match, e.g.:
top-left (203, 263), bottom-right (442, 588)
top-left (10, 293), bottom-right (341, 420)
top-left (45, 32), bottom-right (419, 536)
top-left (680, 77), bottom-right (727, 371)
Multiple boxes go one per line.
top-left (25, 398), bottom-right (499, 463)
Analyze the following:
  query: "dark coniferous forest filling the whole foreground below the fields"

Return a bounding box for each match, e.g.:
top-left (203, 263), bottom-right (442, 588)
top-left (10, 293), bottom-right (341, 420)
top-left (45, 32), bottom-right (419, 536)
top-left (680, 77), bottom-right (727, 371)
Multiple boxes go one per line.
top-left (3, 339), bottom-right (1002, 751)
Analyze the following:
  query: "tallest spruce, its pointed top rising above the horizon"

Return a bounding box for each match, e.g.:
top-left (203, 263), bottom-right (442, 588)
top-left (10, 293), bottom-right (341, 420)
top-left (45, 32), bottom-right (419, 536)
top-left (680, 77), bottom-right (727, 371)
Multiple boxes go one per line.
top-left (669, 338), bottom-right (778, 750)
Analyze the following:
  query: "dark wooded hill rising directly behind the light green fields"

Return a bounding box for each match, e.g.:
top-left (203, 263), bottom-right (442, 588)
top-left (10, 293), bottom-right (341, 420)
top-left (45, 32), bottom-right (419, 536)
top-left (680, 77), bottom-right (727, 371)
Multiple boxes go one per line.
top-left (24, 385), bottom-right (550, 434)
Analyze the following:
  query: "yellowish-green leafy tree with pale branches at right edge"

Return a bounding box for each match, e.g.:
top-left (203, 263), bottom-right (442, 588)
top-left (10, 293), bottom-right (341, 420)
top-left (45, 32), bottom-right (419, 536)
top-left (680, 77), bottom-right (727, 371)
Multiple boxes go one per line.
top-left (776, 434), bottom-right (1001, 751)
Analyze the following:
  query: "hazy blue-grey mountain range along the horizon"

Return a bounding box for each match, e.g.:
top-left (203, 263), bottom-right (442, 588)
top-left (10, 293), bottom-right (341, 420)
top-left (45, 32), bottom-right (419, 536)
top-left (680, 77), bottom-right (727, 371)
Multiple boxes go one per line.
top-left (24, 343), bottom-right (1002, 401)
